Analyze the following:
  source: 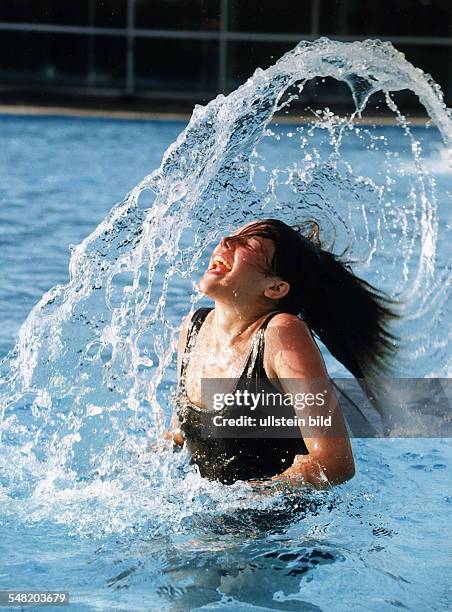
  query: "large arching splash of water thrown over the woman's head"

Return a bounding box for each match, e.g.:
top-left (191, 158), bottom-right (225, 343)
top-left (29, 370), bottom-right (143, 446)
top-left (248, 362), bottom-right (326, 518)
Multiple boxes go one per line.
top-left (0, 39), bottom-right (452, 532)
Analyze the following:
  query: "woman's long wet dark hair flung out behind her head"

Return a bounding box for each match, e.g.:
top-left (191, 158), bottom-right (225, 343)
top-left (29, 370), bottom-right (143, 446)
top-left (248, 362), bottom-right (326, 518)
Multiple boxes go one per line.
top-left (229, 219), bottom-right (398, 378)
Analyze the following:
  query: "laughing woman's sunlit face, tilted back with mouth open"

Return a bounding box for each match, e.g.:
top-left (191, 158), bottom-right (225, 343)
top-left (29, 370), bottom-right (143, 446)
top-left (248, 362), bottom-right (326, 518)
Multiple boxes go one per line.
top-left (199, 224), bottom-right (275, 302)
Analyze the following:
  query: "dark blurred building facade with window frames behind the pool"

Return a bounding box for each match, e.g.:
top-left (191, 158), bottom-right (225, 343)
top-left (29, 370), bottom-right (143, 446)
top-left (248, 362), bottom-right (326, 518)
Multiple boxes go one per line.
top-left (0, 0), bottom-right (452, 112)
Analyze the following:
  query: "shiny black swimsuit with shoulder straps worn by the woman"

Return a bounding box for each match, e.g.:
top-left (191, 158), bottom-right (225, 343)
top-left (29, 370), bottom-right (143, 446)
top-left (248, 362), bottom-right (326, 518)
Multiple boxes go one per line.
top-left (176, 308), bottom-right (308, 484)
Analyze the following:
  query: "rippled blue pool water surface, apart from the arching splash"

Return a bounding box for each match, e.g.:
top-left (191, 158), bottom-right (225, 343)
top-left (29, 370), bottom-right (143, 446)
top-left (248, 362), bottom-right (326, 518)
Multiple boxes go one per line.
top-left (0, 116), bottom-right (452, 611)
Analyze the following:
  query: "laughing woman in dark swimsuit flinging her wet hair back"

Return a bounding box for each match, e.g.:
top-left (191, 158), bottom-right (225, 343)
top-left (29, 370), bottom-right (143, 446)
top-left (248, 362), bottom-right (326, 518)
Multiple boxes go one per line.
top-left (172, 219), bottom-right (394, 488)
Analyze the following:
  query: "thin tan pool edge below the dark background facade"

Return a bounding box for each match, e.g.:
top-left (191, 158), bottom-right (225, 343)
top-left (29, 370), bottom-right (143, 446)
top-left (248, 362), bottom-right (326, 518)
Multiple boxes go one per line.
top-left (0, 104), bottom-right (430, 126)
